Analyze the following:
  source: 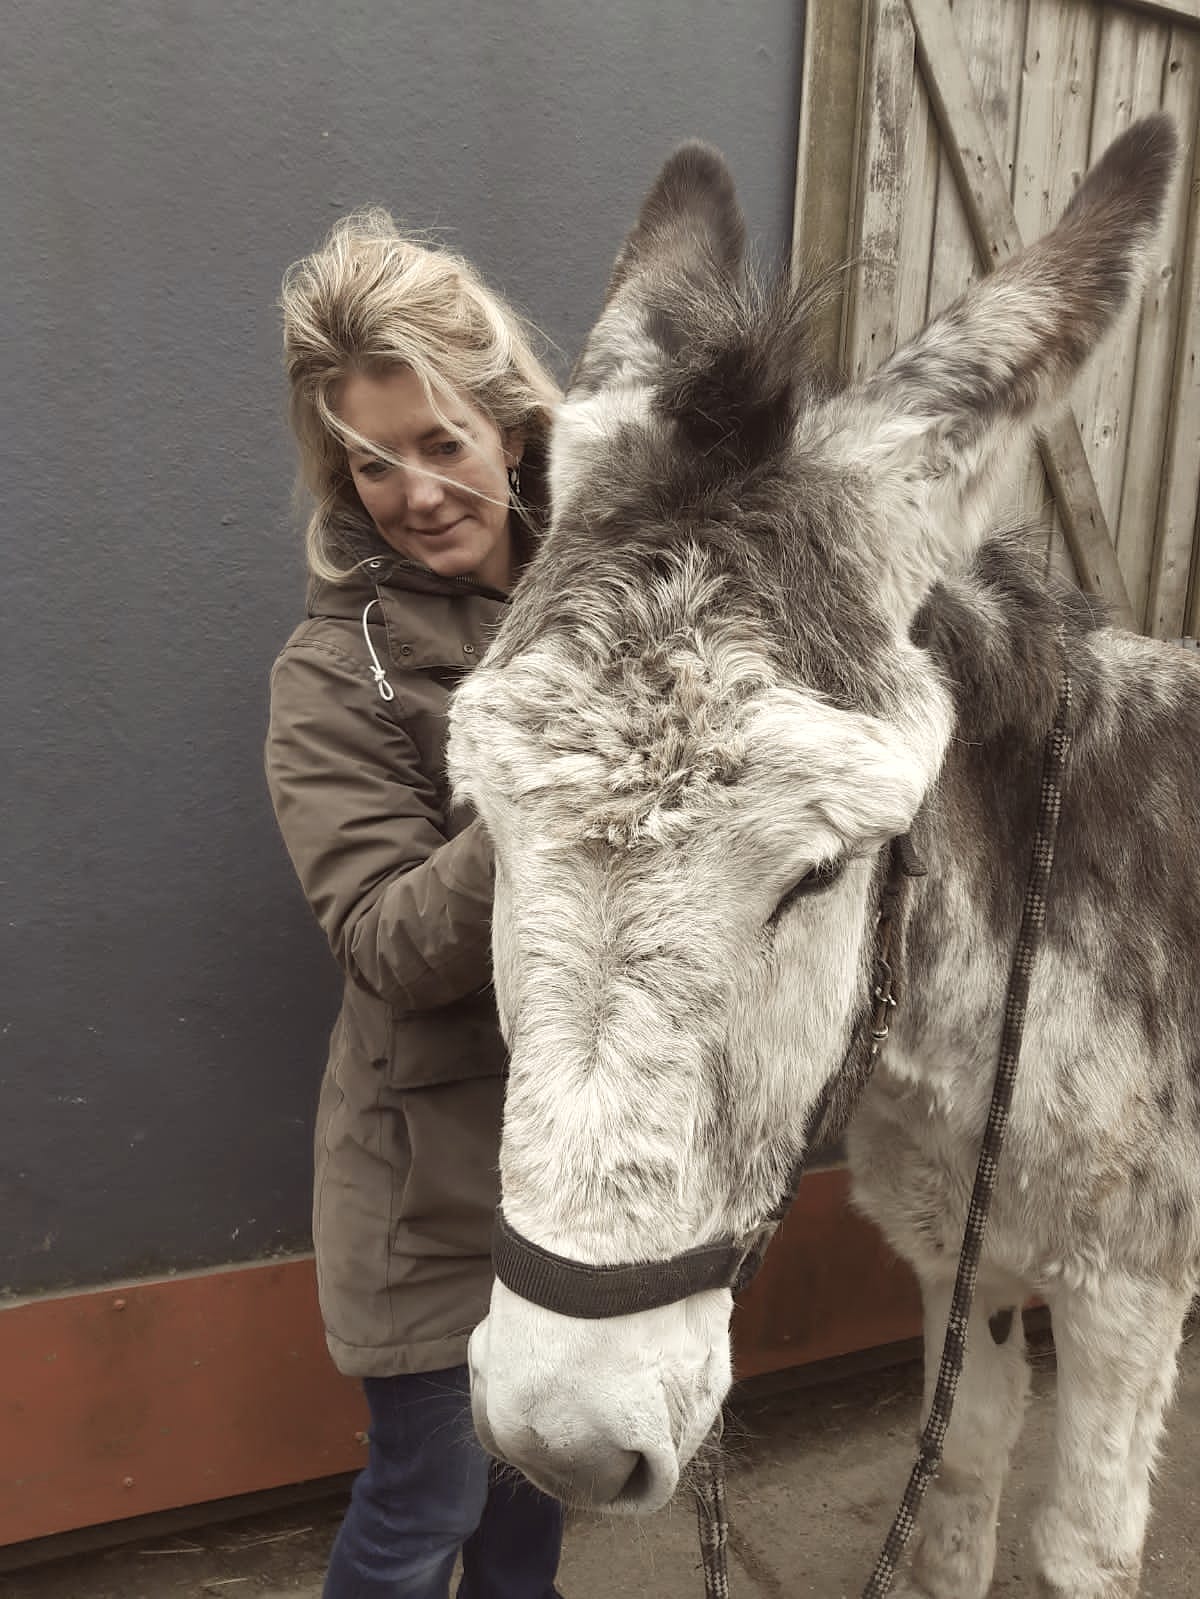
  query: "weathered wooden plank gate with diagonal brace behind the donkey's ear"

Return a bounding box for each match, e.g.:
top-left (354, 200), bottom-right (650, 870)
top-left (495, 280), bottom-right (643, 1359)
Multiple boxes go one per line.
top-left (794, 0), bottom-right (1200, 638)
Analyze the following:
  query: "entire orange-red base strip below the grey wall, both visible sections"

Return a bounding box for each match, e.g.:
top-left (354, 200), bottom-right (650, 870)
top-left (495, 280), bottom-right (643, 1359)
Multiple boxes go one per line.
top-left (0, 1170), bottom-right (920, 1545)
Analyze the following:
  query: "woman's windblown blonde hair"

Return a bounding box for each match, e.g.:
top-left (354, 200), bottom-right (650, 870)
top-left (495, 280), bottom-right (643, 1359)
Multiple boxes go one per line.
top-left (280, 209), bottom-right (558, 582)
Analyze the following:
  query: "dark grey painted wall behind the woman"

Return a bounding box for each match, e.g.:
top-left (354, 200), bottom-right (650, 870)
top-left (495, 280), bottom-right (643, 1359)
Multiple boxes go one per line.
top-left (0, 0), bottom-right (802, 1292)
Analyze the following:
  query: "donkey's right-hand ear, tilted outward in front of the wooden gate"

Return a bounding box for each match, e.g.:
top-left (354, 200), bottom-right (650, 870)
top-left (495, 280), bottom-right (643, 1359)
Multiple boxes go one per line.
top-left (846, 115), bottom-right (1176, 604)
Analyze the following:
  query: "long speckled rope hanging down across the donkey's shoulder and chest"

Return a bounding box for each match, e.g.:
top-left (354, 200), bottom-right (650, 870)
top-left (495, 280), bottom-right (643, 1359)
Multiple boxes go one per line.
top-left (862, 638), bottom-right (1070, 1599)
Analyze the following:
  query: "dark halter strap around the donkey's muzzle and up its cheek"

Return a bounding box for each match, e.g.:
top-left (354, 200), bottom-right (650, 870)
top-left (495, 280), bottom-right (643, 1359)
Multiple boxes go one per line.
top-left (491, 833), bottom-right (925, 1321)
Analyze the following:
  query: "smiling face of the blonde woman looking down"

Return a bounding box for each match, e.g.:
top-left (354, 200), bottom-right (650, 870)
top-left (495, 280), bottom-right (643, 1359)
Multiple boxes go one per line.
top-left (336, 368), bottom-right (520, 588)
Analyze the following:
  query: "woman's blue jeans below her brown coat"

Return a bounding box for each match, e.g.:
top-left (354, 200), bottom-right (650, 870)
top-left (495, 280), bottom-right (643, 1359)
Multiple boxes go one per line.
top-left (323, 1366), bottom-right (563, 1599)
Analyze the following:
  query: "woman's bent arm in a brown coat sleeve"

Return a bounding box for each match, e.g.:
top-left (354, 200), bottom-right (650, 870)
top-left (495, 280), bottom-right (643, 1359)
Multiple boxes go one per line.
top-left (266, 640), bottom-right (493, 1011)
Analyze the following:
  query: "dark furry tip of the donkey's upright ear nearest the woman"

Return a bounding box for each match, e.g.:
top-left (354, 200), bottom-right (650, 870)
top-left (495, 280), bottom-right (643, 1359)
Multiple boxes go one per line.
top-left (606, 139), bottom-right (746, 301)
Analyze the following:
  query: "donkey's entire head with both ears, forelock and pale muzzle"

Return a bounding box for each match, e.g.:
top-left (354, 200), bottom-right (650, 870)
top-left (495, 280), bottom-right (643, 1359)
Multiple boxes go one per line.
top-left (451, 120), bottom-right (1173, 1509)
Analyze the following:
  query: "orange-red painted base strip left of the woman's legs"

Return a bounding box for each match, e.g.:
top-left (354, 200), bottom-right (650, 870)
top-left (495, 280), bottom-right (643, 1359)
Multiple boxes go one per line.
top-left (0, 1257), bottom-right (366, 1545)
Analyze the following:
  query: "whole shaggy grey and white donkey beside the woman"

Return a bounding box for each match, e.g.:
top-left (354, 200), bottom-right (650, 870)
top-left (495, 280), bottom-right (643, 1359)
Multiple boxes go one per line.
top-left (451, 117), bottom-right (1200, 1599)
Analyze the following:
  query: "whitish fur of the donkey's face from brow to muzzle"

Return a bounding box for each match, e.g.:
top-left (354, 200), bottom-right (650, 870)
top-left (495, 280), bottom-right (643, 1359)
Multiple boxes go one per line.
top-left (451, 626), bottom-right (950, 1508)
